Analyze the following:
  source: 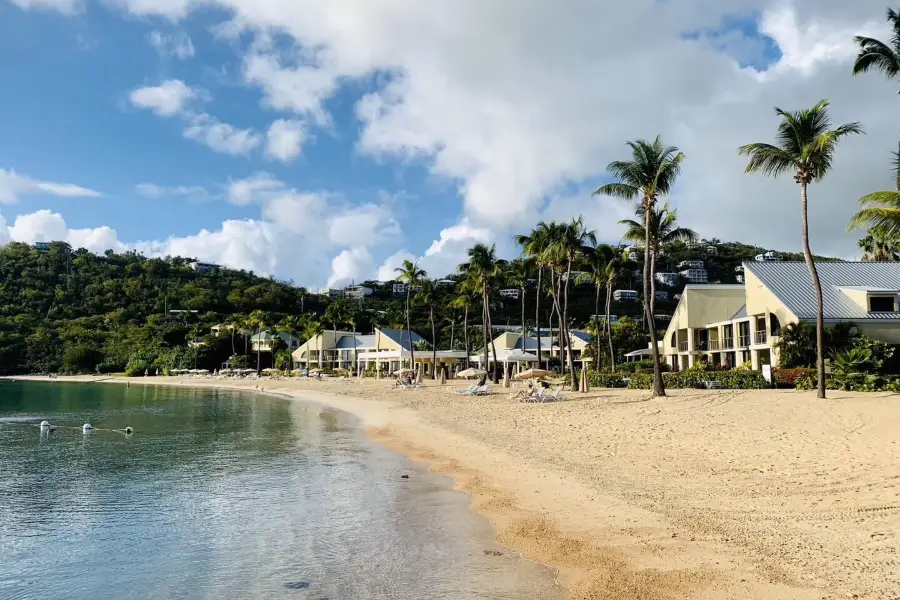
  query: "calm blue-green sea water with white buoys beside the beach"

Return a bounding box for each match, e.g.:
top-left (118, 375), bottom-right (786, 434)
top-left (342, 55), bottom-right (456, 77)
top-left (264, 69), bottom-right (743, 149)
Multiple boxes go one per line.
top-left (0, 381), bottom-right (562, 600)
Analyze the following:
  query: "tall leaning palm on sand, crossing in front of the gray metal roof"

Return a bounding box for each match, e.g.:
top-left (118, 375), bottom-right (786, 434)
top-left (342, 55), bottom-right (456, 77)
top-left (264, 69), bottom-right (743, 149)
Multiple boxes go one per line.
top-left (738, 100), bottom-right (862, 398)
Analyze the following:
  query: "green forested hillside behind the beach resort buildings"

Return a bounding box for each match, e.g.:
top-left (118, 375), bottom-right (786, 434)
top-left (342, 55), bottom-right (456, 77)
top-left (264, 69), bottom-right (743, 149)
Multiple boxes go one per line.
top-left (0, 240), bottom-right (844, 374)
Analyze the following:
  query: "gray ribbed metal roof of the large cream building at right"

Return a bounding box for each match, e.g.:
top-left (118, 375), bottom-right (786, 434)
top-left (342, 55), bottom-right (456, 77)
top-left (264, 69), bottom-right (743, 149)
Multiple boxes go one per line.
top-left (744, 262), bottom-right (900, 321)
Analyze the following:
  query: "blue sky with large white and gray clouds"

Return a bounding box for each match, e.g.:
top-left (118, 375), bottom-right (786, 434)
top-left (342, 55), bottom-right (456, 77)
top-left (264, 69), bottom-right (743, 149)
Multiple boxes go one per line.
top-left (0, 0), bottom-right (900, 289)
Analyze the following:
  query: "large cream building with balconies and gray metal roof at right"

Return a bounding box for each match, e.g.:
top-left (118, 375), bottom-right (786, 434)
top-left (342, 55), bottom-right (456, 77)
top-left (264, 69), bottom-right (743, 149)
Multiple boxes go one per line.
top-left (663, 261), bottom-right (900, 369)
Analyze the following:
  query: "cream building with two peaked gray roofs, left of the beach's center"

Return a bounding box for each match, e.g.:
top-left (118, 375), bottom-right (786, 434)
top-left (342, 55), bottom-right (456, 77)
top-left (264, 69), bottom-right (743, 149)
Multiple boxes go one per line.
top-left (291, 327), bottom-right (466, 376)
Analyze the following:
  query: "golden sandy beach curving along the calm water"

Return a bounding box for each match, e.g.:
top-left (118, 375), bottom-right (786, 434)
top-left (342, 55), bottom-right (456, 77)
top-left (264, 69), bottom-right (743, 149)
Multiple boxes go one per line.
top-left (8, 377), bottom-right (900, 600)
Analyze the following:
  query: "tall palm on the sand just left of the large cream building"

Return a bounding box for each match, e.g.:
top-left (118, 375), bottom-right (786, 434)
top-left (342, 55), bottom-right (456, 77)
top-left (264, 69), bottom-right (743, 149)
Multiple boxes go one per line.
top-left (594, 136), bottom-right (684, 397)
